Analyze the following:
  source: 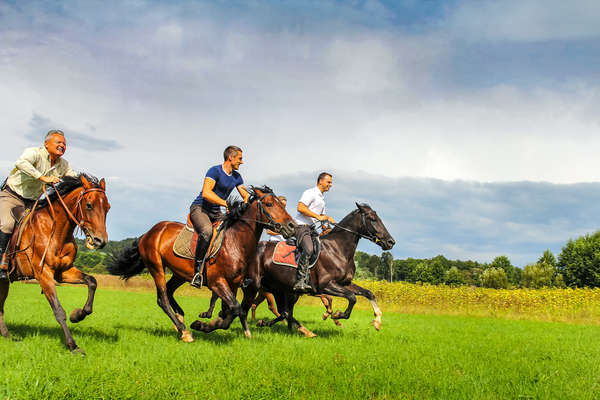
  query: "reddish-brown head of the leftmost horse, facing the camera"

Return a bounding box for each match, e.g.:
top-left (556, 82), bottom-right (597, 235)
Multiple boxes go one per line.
top-left (76, 175), bottom-right (110, 249)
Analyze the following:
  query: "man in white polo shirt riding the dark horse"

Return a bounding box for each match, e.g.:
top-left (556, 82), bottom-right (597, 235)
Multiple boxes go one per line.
top-left (294, 172), bottom-right (335, 293)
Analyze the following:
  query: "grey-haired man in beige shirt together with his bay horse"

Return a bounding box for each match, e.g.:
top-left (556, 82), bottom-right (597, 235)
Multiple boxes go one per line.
top-left (0, 131), bottom-right (110, 353)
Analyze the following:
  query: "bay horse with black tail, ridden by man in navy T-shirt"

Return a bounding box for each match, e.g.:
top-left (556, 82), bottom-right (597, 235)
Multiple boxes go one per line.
top-left (108, 186), bottom-right (296, 342)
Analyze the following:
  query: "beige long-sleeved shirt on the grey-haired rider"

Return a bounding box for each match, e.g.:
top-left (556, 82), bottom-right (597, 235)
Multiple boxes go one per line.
top-left (6, 146), bottom-right (78, 200)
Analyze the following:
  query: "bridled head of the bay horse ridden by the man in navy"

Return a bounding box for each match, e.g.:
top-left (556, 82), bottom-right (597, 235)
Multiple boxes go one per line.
top-left (252, 186), bottom-right (296, 239)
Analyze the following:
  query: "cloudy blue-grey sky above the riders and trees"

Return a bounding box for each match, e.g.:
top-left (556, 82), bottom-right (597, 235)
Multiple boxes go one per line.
top-left (0, 0), bottom-right (600, 266)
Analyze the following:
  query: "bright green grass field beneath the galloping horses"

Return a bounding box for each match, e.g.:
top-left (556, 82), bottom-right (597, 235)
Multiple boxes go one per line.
top-left (0, 284), bottom-right (600, 399)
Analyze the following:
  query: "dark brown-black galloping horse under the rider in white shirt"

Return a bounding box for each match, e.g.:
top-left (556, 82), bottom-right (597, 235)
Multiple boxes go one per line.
top-left (242, 204), bottom-right (395, 337)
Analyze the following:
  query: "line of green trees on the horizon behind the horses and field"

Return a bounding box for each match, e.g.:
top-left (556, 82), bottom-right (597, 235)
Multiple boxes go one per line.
top-left (74, 231), bottom-right (600, 289)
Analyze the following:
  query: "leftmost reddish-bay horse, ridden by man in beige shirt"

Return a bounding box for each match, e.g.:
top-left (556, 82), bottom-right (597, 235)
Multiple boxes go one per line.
top-left (0, 174), bottom-right (110, 354)
